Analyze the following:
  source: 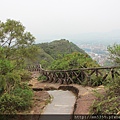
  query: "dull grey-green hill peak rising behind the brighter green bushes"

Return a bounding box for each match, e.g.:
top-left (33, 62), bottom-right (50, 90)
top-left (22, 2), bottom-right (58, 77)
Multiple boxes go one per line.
top-left (38, 39), bottom-right (85, 59)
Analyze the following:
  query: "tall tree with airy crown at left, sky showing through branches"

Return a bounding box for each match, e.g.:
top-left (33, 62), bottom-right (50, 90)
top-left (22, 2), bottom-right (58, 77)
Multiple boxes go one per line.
top-left (0, 19), bottom-right (37, 67)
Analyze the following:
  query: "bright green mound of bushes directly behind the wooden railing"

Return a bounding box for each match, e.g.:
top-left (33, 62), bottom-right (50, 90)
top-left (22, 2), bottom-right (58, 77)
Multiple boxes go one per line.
top-left (49, 52), bottom-right (99, 70)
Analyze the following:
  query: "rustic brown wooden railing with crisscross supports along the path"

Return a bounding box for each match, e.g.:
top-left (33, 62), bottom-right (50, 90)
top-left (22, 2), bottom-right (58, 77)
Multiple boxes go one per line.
top-left (28, 65), bottom-right (120, 84)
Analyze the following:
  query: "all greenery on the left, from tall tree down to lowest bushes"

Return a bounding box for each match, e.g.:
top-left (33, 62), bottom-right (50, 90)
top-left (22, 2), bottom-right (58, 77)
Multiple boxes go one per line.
top-left (0, 19), bottom-right (37, 114)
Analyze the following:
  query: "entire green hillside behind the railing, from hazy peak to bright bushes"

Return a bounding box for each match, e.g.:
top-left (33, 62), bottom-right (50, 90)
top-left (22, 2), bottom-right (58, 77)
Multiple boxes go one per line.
top-left (36, 39), bottom-right (98, 69)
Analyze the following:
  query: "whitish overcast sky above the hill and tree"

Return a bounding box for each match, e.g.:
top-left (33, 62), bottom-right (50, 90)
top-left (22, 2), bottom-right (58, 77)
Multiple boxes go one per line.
top-left (0, 0), bottom-right (120, 42)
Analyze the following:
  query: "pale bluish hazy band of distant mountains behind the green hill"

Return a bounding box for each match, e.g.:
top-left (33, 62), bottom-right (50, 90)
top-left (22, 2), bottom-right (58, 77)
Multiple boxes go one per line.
top-left (36, 30), bottom-right (120, 45)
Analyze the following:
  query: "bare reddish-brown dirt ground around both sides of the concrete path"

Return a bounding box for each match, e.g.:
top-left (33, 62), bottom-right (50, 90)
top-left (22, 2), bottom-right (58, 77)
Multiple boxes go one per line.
top-left (29, 78), bottom-right (105, 114)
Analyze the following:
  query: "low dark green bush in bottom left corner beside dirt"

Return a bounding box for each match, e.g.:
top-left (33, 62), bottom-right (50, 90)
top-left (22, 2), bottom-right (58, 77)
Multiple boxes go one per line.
top-left (0, 84), bottom-right (33, 114)
